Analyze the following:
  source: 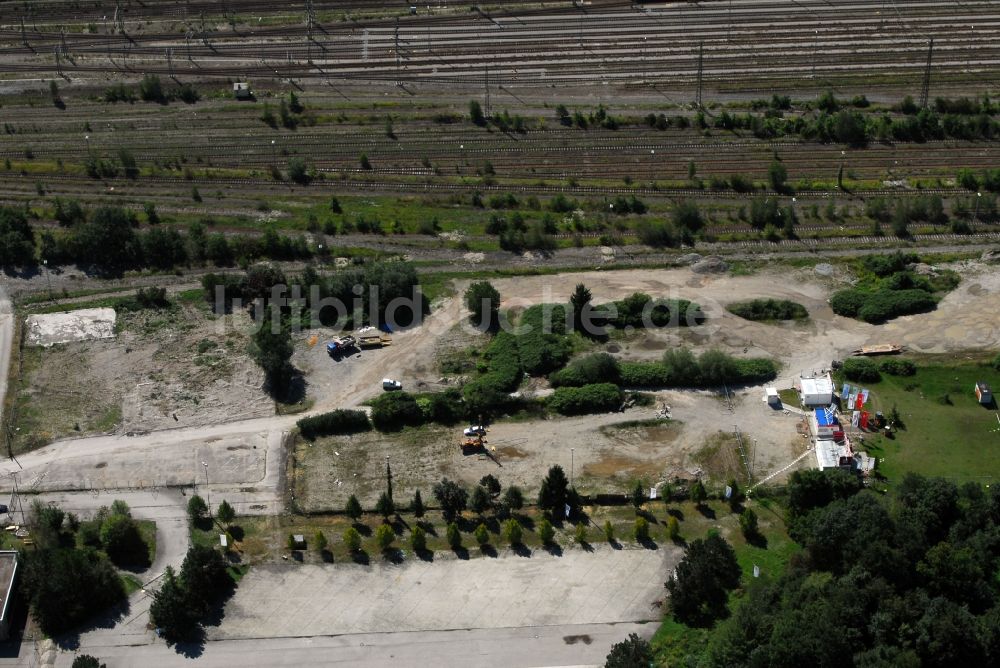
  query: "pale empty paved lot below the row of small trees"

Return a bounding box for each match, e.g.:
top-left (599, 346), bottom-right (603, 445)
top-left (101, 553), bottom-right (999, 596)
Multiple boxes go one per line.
top-left (209, 546), bottom-right (680, 639)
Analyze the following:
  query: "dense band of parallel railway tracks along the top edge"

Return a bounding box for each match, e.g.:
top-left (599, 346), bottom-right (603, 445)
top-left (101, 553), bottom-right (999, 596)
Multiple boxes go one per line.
top-left (0, 0), bottom-right (1000, 94)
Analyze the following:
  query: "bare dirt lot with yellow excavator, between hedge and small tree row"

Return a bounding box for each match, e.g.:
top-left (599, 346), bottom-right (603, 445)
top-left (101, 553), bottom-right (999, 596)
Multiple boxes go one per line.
top-left (295, 391), bottom-right (808, 512)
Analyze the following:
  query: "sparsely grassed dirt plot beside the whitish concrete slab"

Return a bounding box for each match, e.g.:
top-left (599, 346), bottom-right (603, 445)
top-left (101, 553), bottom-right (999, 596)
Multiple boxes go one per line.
top-left (17, 304), bottom-right (274, 450)
